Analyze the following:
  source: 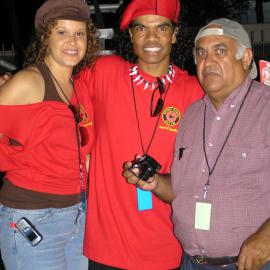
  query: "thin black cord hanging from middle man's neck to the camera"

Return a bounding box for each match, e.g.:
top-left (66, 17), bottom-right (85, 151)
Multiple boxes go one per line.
top-left (130, 66), bottom-right (172, 154)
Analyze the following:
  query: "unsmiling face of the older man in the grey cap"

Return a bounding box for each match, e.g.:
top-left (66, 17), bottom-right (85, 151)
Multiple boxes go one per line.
top-left (195, 36), bottom-right (252, 108)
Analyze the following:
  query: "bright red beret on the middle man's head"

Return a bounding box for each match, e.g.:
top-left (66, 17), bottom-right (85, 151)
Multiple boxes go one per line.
top-left (120, 0), bottom-right (180, 30)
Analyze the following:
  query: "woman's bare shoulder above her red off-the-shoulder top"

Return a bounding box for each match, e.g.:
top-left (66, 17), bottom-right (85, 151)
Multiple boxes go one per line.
top-left (0, 66), bottom-right (45, 105)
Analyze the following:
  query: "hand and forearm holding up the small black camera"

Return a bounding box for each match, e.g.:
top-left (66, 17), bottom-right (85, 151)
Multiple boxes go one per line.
top-left (123, 162), bottom-right (175, 203)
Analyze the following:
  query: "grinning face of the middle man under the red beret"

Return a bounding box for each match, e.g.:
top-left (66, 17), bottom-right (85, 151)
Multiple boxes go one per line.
top-left (129, 15), bottom-right (176, 74)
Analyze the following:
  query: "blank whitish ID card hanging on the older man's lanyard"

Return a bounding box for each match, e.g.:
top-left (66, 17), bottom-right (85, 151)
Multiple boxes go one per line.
top-left (194, 202), bottom-right (212, 231)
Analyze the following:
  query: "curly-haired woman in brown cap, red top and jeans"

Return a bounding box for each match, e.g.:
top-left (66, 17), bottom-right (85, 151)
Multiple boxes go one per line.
top-left (0, 0), bottom-right (98, 270)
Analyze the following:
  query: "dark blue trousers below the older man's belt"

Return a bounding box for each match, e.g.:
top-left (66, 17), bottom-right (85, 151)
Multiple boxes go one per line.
top-left (180, 253), bottom-right (270, 270)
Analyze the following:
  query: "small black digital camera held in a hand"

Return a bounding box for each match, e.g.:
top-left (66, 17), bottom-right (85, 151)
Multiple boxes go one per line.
top-left (130, 154), bottom-right (161, 181)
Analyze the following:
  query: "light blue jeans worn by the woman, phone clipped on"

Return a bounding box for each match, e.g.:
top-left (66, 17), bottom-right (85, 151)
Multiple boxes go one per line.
top-left (0, 204), bottom-right (88, 270)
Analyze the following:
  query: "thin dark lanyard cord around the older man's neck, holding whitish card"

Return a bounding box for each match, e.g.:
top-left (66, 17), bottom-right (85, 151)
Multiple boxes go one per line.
top-left (203, 81), bottom-right (253, 199)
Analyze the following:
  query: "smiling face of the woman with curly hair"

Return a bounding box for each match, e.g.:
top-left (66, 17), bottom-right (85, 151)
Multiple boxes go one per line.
top-left (45, 20), bottom-right (87, 68)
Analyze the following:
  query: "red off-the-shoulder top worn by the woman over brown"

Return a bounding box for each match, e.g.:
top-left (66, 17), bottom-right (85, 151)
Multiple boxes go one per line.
top-left (0, 79), bottom-right (94, 194)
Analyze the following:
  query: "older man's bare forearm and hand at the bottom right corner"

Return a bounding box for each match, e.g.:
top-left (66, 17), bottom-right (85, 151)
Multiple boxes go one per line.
top-left (237, 219), bottom-right (270, 270)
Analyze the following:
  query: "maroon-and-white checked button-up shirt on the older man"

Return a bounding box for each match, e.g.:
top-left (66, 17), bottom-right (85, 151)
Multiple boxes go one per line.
top-left (172, 78), bottom-right (270, 257)
